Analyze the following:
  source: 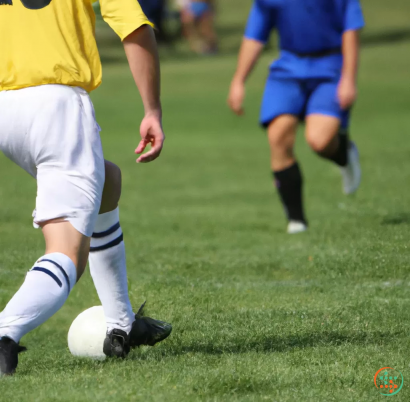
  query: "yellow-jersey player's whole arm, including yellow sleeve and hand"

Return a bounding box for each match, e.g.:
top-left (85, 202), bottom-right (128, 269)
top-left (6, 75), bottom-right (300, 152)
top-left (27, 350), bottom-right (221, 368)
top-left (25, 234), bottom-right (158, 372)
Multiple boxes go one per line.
top-left (100, 0), bottom-right (165, 163)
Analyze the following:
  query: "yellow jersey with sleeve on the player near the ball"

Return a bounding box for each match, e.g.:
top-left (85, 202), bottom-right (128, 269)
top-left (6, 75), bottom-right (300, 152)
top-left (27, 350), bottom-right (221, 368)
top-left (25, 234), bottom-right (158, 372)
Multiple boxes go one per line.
top-left (0, 0), bottom-right (152, 92)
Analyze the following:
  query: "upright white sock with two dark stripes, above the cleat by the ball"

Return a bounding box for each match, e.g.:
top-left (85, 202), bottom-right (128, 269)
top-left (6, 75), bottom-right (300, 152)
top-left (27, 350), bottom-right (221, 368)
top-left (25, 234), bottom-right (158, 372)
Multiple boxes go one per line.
top-left (89, 208), bottom-right (135, 333)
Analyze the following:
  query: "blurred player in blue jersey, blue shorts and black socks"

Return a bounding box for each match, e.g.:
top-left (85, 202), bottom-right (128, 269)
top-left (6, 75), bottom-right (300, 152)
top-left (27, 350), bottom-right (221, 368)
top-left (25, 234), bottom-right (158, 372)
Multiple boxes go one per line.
top-left (228, 0), bottom-right (364, 233)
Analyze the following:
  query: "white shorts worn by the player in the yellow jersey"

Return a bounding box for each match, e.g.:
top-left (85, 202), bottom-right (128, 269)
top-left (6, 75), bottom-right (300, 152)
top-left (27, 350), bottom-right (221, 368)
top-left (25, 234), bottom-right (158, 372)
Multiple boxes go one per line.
top-left (0, 85), bottom-right (105, 236)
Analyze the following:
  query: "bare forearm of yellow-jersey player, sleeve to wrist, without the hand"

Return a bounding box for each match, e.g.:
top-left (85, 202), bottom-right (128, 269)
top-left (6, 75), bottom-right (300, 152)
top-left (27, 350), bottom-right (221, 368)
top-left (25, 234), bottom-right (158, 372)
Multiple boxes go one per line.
top-left (123, 25), bottom-right (161, 115)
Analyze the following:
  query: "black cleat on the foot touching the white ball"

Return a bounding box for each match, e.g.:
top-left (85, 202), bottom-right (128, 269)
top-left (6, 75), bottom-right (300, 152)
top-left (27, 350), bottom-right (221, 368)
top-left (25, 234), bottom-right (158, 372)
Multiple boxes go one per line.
top-left (103, 303), bottom-right (172, 358)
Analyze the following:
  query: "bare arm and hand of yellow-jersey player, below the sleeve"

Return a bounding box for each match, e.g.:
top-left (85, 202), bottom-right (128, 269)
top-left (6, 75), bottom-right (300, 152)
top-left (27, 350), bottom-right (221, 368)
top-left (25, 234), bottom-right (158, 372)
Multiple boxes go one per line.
top-left (123, 25), bottom-right (165, 163)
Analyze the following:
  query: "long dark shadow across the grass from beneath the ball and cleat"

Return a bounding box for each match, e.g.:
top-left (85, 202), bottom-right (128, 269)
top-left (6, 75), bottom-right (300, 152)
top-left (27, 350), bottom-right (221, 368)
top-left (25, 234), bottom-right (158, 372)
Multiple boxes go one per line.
top-left (18, 332), bottom-right (405, 377)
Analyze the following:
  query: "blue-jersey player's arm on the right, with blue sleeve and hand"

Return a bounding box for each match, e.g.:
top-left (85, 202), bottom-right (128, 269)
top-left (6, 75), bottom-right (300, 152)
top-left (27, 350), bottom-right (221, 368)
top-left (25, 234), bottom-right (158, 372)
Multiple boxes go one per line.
top-left (337, 0), bottom-right (364, 110)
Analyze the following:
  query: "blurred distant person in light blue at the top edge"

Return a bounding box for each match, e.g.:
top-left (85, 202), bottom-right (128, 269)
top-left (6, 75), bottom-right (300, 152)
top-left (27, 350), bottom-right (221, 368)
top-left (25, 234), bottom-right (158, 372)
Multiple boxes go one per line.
top-left (178, 0), bottom-right (218, 55)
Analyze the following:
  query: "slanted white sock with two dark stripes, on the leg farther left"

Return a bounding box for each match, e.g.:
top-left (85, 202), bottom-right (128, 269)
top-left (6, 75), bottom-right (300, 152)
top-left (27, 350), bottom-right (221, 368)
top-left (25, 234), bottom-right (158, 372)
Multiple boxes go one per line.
top-left (0, 253), bottom-right (77, 342)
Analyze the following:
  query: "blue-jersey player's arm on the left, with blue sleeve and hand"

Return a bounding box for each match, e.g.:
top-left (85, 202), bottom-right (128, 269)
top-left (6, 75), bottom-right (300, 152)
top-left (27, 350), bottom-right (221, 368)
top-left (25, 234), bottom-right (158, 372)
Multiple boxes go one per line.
top-left (228, 0), bottom-right (274, 115)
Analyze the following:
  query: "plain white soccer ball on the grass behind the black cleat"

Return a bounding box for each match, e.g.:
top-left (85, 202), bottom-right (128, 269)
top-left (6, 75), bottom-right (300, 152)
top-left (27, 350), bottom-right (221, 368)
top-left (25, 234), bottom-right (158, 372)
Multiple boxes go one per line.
top-left (67, 306), bottom-right (107, 360)
